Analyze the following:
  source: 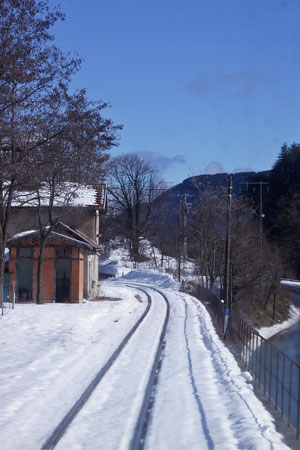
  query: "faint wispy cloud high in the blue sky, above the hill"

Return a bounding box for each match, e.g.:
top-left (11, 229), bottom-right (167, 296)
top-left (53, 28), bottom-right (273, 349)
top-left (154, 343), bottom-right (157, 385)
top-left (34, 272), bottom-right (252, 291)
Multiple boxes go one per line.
top-left (186, 72), bottom-right (275, 98)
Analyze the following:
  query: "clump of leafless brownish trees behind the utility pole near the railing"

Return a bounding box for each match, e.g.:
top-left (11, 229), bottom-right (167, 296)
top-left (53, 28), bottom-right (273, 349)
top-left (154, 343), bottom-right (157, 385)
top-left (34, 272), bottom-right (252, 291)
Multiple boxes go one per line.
top-left (190, 185), bottom-right (288, 323)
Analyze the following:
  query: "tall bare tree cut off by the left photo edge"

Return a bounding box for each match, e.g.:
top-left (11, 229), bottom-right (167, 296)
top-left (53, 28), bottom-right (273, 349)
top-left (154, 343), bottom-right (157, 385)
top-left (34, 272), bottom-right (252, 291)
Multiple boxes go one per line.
top-left (0, 0), bottom-right (80, 284)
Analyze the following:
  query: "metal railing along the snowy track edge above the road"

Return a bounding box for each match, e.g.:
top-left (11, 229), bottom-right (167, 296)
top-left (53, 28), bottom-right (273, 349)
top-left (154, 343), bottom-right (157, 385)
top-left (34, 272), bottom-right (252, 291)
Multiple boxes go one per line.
top-left (192, 286), bottom-right (300, 439)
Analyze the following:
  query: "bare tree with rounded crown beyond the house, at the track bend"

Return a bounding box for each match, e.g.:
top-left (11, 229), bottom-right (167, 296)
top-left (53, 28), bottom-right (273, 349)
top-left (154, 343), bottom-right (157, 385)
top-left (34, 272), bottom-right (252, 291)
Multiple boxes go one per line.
top-left (107, 153), bottom-right (163, 261)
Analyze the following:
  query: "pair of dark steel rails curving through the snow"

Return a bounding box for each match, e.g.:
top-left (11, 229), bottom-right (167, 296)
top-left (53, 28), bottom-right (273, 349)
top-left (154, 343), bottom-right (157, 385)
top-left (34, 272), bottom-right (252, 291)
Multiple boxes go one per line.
top-left (41, 283), bottom-right (170, 450)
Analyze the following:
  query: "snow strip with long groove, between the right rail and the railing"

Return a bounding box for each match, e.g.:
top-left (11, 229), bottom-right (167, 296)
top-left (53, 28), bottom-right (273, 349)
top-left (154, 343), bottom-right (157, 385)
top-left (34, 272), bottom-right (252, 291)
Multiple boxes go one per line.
top-left (145, 292), bottom-right (287, 450)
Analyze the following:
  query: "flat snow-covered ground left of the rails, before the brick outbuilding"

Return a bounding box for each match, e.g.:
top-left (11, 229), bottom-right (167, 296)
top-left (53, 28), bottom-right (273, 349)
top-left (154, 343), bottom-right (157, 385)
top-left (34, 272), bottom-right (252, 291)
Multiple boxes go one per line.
top-left (0, 286), bottom-right (145, 450)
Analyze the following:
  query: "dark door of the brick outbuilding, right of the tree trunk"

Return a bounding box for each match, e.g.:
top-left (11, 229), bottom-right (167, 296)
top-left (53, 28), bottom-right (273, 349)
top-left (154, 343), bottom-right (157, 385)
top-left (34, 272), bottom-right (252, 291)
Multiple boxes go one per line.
top-left (55, 249), bottom-right (72, 303)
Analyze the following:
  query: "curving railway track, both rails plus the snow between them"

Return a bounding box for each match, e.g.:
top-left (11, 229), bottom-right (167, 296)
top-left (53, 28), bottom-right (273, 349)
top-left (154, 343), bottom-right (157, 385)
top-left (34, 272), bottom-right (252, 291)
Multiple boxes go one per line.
top-left (42, 283), bottom-right (169, 450)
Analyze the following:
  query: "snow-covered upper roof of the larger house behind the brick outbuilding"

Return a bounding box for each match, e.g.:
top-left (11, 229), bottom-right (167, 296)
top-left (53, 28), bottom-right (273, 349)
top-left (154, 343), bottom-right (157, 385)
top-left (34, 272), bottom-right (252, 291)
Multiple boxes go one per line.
top-left (12, 183), bottom-right (107, 210)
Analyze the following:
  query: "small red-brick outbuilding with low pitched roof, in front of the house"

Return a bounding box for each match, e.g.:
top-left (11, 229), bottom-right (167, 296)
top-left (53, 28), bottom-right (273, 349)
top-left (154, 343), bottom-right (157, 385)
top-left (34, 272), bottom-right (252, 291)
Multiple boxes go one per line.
top-left (7, 222), bottom-right (99, 303)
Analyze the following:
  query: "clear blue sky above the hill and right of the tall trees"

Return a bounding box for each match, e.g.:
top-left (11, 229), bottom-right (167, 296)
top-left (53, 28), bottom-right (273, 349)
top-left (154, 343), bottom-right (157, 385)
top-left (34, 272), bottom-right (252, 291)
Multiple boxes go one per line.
top-left (54, 0), bottom-right (300, 183)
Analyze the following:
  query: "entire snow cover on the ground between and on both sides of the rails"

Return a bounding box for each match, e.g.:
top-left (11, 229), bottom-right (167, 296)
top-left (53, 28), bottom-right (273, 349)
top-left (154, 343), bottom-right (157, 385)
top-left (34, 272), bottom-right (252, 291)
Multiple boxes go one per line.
top-left (0, 248), bottom-right (288, 450)
